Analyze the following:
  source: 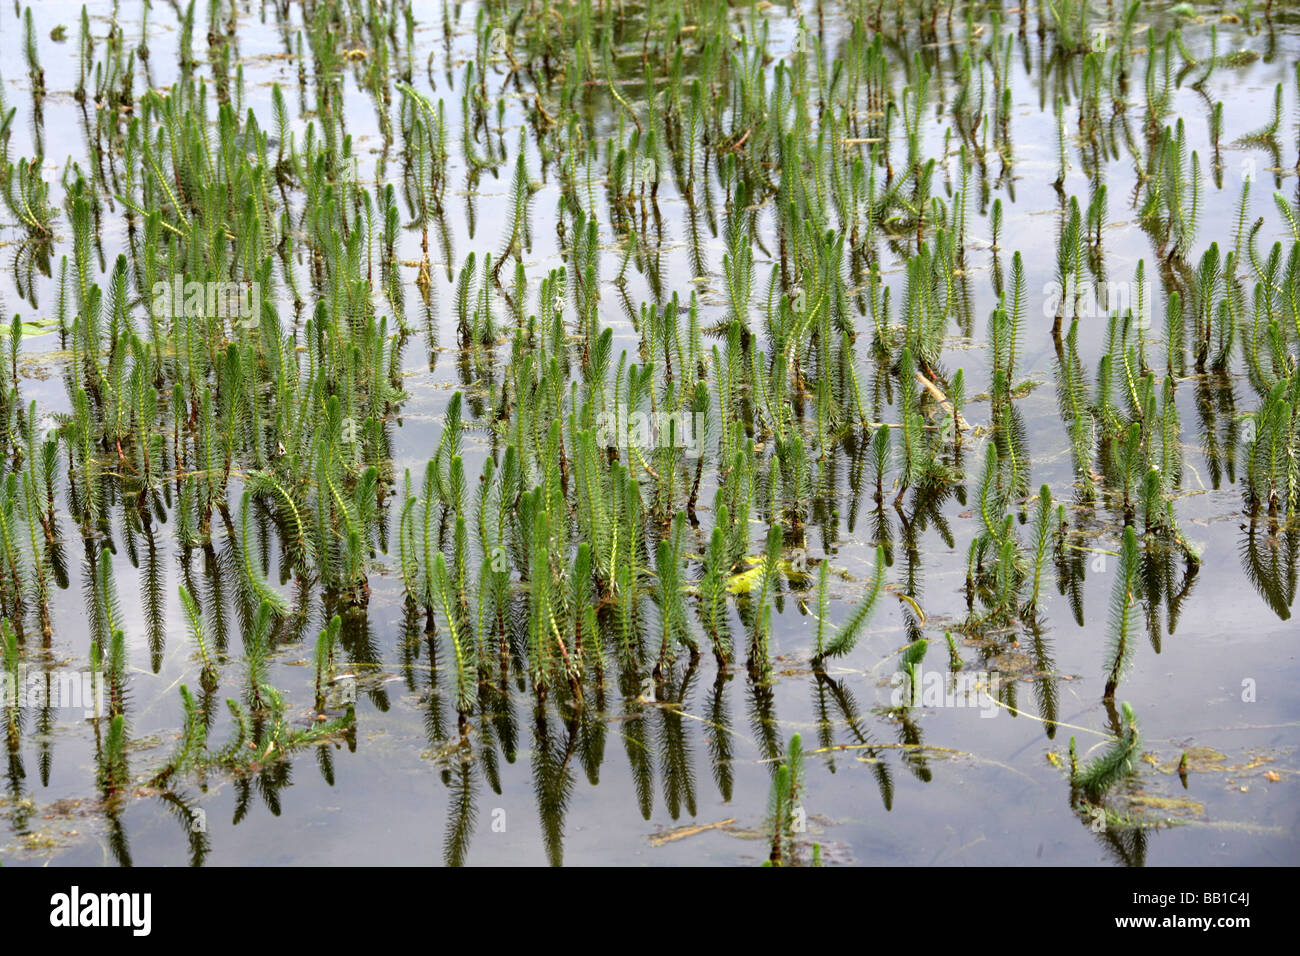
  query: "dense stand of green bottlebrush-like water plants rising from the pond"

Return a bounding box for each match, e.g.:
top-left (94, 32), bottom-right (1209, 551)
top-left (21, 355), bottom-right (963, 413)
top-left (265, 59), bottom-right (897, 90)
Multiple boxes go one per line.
top-left (0, 0), bottom-right (1300, 865)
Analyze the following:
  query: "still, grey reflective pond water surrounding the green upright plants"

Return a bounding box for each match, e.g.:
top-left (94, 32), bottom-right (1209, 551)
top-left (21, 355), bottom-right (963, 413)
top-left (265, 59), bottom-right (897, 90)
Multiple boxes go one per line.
top-left (0, 3), bottom-right (1300, 865)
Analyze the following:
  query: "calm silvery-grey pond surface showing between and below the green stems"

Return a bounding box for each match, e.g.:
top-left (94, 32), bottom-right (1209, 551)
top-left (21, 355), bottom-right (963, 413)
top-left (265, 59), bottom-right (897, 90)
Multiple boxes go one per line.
top-left (0, 3), bottom-right (1300, 866)
